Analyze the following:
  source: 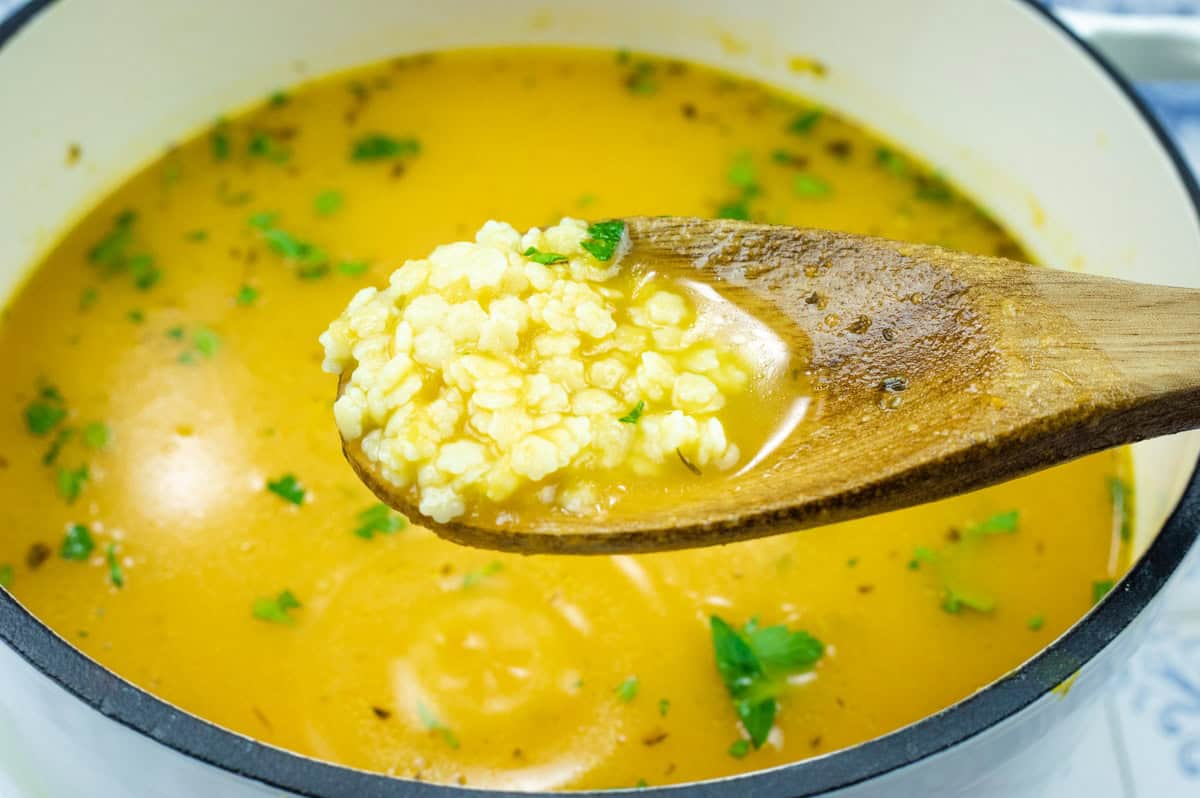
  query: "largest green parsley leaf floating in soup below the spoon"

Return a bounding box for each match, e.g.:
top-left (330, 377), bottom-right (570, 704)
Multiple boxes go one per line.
top-left (709, 616), bottom-right (824, 754)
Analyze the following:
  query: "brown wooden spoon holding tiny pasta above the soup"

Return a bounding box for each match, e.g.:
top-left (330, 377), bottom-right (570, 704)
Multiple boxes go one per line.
top-left (340, 217), bottom-right (1200, 553)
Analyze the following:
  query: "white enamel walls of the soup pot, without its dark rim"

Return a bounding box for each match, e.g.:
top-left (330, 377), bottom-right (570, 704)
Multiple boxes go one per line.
top-left (0, 0), bottom-right (1200, 798)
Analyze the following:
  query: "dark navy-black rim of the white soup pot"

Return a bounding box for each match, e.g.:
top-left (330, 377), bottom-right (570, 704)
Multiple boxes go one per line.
top-left (0, 0), bottom-right (1200, 798)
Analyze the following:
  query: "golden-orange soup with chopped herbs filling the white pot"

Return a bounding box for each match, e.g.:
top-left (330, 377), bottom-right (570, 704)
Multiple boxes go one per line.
top-left (0, 49), bottom-right (1132, 790)
